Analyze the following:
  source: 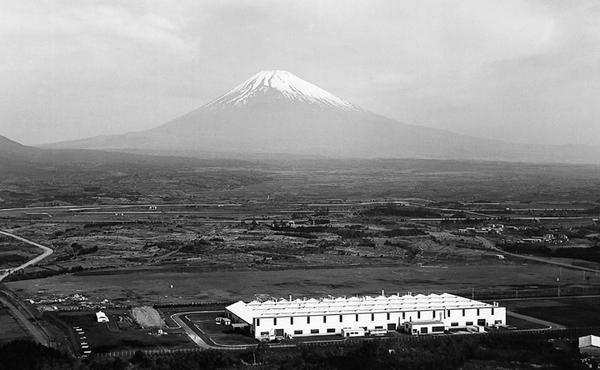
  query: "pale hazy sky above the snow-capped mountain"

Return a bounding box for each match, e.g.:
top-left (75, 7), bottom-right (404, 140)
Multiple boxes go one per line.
top-left (0, 0), bottom-right (600, 144)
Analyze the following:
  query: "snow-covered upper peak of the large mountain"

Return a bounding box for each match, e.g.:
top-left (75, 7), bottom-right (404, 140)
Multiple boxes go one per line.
top-left (206, 70), bottom-right (361, 111)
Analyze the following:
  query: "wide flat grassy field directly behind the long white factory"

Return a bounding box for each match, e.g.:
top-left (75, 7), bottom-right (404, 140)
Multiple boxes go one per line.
top-left (7, 263), bottom-right (598, 305)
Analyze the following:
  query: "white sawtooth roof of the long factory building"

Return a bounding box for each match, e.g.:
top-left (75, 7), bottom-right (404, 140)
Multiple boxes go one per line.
top-left (226, 293), bottom-right (493, 323)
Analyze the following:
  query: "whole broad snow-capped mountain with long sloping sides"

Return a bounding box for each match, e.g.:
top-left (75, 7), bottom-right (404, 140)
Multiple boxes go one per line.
top-left (50, 70), bottom-right (600, 162)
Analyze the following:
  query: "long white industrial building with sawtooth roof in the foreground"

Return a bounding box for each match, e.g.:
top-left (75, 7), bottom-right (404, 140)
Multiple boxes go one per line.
top-left (226, 293), bottom-right (506, 339)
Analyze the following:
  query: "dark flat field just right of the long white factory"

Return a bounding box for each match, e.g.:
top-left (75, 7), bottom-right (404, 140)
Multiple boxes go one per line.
top-left (502, 297), bottom-right (600, 327)
